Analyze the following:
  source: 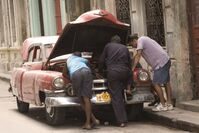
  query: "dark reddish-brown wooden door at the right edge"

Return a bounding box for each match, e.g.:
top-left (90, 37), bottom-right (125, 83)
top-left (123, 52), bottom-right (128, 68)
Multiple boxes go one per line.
top-left (187, 0), bottom-right (199, 98)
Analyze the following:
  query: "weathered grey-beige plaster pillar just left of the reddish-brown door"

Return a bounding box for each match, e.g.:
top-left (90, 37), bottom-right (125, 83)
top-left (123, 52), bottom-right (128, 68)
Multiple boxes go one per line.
top-left (163, 0), bottom-right (192, 102)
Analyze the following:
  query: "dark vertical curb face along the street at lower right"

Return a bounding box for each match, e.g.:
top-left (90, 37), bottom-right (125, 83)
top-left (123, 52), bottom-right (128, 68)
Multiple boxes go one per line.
top-left (144, 109), bottom-right (199, 133)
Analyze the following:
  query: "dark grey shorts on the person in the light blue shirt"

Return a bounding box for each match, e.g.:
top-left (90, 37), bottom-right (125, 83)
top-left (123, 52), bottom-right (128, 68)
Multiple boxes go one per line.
top-left (71, 68), bottom-right (93, 98)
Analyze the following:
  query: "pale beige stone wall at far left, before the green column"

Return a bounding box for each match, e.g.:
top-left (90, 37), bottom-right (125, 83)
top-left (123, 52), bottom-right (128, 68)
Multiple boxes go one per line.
top-left (0, 0), bottom-right (29, 72)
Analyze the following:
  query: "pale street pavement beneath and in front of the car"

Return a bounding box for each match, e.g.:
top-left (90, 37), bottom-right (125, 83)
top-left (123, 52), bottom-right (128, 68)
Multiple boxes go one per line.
top-left (0, 73), bottom-right (196, 133)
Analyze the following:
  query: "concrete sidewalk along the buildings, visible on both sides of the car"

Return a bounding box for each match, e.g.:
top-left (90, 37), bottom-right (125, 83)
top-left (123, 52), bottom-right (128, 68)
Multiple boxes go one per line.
top-left (0, 73), bottom-right (199, 133)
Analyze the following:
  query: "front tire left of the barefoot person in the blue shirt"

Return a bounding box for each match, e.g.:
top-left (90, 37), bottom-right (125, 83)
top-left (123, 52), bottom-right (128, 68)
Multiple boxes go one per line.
top-left (45, 106), bottom-right (66, 126)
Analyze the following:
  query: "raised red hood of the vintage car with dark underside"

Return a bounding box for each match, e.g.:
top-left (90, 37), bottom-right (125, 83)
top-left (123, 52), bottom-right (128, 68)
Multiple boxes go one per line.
top-left (47, 10), bottom-right (130, 62)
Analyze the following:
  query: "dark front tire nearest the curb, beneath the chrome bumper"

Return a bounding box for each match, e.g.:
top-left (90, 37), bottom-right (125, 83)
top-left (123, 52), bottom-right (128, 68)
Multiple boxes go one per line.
top-left (127, 103), bottom-right (143, 121)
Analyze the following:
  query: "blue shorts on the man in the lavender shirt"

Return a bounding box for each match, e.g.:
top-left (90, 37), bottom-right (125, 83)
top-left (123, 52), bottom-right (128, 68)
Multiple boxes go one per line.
top-left (153, 60), bottom-right (171, 84)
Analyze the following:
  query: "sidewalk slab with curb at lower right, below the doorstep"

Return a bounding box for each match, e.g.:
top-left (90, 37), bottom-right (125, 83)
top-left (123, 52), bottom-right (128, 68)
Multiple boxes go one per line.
top-left (144, 107), bottom-right (199, 133)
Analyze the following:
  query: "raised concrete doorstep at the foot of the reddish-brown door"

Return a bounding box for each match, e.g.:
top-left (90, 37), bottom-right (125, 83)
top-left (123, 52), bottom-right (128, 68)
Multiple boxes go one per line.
top-left (178, 100), bottom-right (199, 113)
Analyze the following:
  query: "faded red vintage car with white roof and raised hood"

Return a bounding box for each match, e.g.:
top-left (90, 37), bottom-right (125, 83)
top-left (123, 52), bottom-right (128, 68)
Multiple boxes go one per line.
top-left (10, 10), bottom-right (154, 125)
